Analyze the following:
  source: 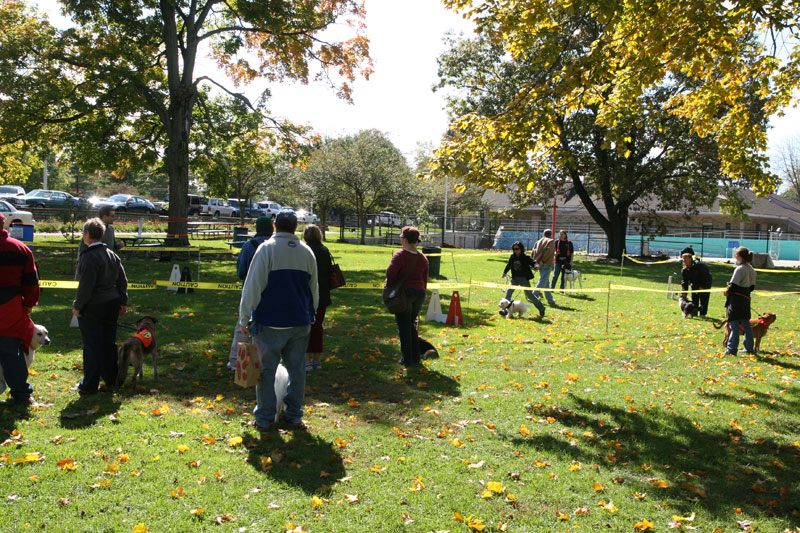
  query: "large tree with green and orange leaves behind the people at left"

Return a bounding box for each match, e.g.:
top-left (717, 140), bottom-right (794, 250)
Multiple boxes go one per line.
top-left (0, 0), bottom-right (370, 243)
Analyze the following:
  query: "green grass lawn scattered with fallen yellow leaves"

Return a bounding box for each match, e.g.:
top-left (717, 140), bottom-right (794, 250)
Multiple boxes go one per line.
top-left (0, 241), bottom-right (800, 532)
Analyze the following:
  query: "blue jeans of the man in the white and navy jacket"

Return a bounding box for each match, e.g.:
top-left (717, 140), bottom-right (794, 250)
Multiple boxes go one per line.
top-left (253, 324), bottom-right (311, 428)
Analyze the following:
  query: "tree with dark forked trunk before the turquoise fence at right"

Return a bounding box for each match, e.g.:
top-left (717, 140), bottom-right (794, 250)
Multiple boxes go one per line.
top-left (432, 17), bottom-right (766, 259)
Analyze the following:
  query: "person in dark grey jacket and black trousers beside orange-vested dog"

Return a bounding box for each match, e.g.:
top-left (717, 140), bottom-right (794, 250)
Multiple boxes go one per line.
top-left (72, 218), bottom-right (128, 395)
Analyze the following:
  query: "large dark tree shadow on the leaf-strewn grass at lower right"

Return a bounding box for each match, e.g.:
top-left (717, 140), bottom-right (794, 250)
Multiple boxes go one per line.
top-left (503, 395), bottom-right (800, 525)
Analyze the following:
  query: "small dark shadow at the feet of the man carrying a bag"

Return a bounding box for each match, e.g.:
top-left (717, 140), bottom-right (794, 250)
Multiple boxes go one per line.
top-left (244, 429), bottom-right (346, 494)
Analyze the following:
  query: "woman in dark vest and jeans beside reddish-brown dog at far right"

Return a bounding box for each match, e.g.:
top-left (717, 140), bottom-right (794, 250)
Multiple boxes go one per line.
top-left (725, 246), bottom-right (756, 355)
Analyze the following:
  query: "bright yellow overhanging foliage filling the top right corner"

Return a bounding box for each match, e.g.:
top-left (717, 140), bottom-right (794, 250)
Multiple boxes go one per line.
top-left (444, 0), bottom-right (800, 195)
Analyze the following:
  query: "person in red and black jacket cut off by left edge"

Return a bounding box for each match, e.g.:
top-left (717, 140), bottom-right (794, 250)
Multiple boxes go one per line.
top-left (0, 213), bottom-right (39, 405)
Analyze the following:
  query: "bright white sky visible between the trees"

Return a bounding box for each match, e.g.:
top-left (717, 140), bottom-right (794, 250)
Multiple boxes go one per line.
top-left (34, 0), bottom-right (800, 170)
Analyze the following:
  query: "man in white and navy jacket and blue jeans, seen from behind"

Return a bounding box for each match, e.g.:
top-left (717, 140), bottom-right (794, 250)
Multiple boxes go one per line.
top-left (239, 209), bottom-right (319, 432)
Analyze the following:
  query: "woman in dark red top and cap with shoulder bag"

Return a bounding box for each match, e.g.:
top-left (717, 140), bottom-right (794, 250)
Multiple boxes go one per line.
top-left (386, 226), bottom-right (428, 367)
